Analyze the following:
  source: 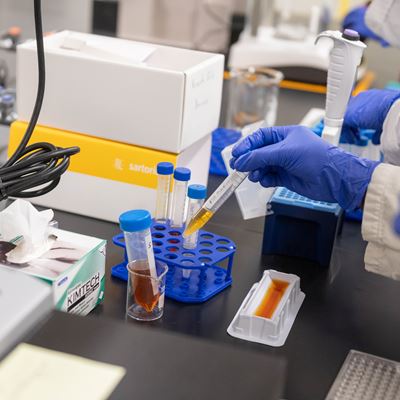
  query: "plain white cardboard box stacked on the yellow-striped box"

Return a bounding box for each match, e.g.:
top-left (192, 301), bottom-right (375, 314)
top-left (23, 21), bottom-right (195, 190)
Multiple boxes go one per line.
top-left (17, 31), bottom-right (224, 153)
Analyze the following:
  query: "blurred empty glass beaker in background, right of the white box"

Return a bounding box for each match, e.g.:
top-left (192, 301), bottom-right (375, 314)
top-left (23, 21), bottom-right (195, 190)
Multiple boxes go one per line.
top-left (226, 67), bottom-right (283, 129)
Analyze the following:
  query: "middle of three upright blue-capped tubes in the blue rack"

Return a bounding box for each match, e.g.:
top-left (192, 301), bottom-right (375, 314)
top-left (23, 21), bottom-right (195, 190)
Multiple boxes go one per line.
top-left (171, 168), bottom-right (190, 228)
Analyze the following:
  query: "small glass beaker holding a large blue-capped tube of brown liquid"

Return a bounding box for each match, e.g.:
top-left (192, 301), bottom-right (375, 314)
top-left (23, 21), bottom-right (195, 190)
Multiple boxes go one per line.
top-left (126, 260), bottom-right (168, 321)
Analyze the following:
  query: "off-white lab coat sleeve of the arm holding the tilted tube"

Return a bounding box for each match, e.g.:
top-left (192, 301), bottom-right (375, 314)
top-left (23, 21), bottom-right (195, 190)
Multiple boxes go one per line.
top-left (362, 164), bottom-right (400, 280)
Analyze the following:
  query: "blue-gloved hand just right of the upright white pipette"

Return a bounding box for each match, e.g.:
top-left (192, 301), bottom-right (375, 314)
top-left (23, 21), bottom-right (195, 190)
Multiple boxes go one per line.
top-left (341, 89), bottom-right (400, 144)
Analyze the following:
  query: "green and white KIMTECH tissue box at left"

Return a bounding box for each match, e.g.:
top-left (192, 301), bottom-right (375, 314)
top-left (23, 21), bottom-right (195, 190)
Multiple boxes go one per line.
top-left (0, 229), bottom-right (106, 315)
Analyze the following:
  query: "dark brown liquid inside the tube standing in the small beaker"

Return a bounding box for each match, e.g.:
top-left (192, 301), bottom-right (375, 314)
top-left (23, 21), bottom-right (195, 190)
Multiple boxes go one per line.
top-left (131, 262), bottom-right (160, 312)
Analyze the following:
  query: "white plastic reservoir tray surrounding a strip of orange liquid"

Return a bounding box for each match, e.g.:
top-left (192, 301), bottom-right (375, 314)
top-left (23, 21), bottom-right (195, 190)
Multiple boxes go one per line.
top-left (227, 270), bottom-right (305, 347)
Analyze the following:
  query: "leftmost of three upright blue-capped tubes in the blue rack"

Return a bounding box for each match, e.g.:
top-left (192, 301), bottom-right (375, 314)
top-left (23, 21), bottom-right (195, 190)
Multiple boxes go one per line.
top-left (154, 162), bottom-right (174, 224)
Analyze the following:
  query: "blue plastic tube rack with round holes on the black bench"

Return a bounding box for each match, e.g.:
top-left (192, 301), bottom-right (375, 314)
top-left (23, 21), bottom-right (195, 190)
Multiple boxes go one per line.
top-left (111, 222), bottom-right (236, 303)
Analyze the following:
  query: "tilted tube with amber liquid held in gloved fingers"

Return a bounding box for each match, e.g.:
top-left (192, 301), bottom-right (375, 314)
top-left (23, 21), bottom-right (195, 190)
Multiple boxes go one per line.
top-left (183, 171), bottom-right (249, 238)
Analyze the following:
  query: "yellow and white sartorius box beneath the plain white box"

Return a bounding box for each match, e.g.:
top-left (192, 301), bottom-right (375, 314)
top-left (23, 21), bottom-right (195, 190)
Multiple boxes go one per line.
top-left (8, 121), bottom-right (211, 222)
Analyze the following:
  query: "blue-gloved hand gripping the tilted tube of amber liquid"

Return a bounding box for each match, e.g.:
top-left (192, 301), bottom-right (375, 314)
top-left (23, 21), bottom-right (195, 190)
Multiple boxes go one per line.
top-left (231, 125), bottom-right (379, 210)
